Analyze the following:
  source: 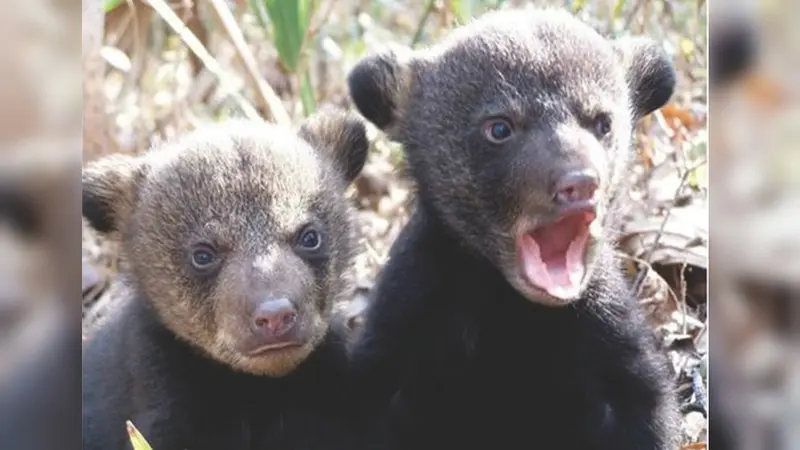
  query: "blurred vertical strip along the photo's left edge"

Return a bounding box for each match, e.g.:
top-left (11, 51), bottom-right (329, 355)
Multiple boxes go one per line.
top-left (0, 0), bottom-right (82, 450)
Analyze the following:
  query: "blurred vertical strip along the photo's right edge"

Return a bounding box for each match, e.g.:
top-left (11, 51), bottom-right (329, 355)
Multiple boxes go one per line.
top-left (709, 0), bottom-right (800, 450)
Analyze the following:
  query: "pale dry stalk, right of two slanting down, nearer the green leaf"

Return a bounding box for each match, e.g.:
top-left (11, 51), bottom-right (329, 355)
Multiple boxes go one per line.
top-left (209, 0), bottom-right (291, 126)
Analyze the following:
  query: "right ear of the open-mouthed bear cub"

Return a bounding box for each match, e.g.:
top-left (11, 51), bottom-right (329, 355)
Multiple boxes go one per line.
top-left (614, 37), bottom-right (676, 120)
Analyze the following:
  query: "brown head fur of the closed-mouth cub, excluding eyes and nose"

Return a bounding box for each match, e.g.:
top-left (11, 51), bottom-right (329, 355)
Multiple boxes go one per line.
top-left (83, 110), bottom-right (366, 376)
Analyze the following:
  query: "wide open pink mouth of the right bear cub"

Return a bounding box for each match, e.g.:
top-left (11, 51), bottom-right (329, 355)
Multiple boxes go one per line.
top-left (517, 210), bottom-right (596, 300)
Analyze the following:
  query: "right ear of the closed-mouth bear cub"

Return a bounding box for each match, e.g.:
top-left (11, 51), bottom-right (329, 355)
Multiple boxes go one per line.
top-left (298, 108), bottom-right (369, 185)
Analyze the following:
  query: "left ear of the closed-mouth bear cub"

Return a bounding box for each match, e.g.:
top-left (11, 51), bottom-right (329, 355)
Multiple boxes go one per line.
top-left (81, 154), bottom-right (142, 233)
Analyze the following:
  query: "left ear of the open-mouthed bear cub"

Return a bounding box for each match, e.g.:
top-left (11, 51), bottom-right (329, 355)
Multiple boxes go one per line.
top-left (347, 48), bottom-right (413, 135)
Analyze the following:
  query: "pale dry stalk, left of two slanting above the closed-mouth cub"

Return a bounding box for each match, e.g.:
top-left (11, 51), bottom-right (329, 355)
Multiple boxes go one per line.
top-left (143, 0), bottom-right (263, 120)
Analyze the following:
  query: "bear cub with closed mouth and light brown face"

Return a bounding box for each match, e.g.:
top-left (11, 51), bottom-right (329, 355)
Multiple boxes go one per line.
top-left (83, 111), bottom-right (384, 450)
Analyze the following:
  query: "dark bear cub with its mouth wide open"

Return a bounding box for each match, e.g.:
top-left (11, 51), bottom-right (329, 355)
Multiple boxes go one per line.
top-left (349, 9), bottom-right (677, 450)
